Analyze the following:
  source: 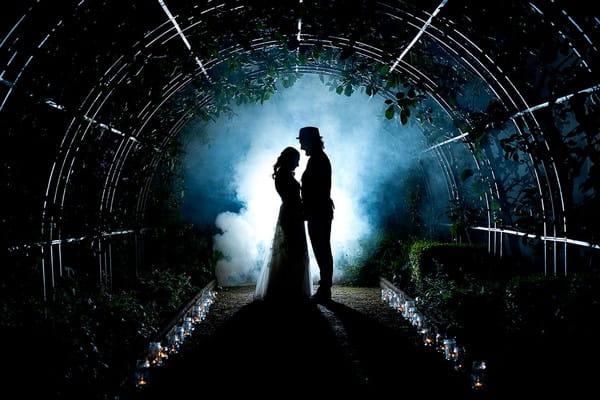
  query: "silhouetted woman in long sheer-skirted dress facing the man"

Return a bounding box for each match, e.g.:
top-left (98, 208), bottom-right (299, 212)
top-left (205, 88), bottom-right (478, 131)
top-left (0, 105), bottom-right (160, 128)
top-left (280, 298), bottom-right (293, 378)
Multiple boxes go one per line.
top-left (254, 147), bottom-right (312, 300)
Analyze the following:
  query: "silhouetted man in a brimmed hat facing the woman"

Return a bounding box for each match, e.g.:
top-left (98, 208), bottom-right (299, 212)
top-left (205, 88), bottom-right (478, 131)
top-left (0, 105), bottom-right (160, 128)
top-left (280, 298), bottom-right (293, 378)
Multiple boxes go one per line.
top-left (297, 126), bottom-right (334, 303)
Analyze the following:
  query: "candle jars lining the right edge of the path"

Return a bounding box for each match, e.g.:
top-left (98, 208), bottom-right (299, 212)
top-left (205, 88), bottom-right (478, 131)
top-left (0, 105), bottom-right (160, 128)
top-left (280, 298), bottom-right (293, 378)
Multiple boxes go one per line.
top-left (381, 288), bottom-right (486, 390)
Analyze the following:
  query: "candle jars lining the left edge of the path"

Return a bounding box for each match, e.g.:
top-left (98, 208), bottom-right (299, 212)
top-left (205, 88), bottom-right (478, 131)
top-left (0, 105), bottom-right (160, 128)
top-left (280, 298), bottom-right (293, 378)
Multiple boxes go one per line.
top-left (135, 289), bottom-right (217, 388)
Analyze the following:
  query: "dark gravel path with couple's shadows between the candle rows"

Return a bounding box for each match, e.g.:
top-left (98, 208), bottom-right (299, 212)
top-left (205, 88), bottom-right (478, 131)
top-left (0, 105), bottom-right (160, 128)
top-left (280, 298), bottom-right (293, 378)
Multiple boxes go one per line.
top-left (126, 286), bottom-right (471, 399)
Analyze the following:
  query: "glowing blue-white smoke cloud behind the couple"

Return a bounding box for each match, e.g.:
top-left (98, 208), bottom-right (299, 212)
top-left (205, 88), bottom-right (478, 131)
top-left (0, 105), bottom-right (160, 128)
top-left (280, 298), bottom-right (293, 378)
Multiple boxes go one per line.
top-left (182, 75), bottom-right (423, 285)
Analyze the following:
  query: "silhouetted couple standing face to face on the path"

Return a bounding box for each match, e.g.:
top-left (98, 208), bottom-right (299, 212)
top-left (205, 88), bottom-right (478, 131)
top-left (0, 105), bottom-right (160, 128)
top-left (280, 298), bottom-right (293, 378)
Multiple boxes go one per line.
top-left (254, 126), bottom-right (334, 303)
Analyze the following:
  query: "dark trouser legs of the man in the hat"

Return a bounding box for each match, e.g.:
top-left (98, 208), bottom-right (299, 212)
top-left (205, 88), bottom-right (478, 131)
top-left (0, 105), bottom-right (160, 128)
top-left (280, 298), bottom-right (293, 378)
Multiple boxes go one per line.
top-left (307, 219), bottom-right (333, 289)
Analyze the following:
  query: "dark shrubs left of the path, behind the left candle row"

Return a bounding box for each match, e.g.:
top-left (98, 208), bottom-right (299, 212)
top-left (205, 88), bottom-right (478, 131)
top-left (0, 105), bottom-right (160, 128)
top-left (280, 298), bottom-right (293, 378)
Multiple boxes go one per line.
top-left (0, 140), bottom-right (218, 399)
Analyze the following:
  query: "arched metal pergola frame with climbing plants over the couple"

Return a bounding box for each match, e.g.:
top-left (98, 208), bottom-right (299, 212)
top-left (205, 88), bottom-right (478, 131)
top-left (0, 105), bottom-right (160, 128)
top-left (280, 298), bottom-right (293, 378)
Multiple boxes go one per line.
top-left (0, 0), bottom-right (600, 297)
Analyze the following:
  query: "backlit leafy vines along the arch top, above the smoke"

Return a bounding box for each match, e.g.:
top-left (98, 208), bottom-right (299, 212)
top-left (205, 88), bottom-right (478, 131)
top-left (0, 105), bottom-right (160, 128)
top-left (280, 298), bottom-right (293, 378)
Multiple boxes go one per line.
top-left (204, 46), bottom-right (425, 125)
